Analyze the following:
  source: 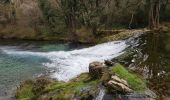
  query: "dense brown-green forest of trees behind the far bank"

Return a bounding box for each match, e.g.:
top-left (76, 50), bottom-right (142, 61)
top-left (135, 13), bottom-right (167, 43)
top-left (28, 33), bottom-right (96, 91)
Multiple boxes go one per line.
top-left (0, 0), bottom-right (170, 41)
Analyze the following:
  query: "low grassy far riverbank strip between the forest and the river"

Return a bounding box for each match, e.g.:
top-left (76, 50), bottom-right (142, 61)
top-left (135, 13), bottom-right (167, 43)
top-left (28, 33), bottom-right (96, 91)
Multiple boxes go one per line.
top-left (0, 29), bottom-right (150, 44)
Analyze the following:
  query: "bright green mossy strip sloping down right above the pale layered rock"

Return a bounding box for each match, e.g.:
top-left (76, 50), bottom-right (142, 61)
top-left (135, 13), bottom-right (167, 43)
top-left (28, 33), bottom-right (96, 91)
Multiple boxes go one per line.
top-left (111, 64), bottom-right (146, 92)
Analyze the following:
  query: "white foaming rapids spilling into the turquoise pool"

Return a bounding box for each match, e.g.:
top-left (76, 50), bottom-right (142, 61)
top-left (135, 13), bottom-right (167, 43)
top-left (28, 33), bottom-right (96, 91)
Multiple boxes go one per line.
top-left (2, 41), bottom-right (129, 81)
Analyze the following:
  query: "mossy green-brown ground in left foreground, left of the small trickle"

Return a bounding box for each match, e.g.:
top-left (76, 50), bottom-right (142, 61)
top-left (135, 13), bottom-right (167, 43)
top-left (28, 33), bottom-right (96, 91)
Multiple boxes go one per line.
top-left (16, 73), bottom-right (99, 100)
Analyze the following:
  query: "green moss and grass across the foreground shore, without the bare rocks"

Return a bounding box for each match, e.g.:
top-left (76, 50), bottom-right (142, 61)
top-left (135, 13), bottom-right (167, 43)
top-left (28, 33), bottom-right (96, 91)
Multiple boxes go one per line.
top-left (16, 64), bottom-right (146, 100)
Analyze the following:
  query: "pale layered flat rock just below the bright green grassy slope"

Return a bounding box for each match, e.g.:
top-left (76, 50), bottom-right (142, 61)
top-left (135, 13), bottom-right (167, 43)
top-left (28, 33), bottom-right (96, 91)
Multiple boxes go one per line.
top-left (108, 75), bottom-right (133, 94)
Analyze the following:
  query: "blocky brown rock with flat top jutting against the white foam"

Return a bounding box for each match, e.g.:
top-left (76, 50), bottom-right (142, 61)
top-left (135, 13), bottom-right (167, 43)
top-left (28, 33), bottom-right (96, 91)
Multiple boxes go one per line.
top-left (89, 62), bottom-right (105, 78)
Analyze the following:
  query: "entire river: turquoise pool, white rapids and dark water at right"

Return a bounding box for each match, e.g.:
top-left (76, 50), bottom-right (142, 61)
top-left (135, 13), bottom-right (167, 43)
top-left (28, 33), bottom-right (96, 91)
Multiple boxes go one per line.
top-left (0, 31), bottom-right (170, 100)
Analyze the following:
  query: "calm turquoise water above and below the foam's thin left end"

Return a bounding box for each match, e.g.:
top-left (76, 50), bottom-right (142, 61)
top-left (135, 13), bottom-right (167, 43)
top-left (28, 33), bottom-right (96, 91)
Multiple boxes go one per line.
top-left (0, 41), bottom-right (71, 100)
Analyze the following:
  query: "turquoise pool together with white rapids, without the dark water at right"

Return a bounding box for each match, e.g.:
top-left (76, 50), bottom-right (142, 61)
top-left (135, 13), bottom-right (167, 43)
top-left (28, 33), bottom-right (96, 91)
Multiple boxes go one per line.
top-left (0, 36), bottom-right (138, 100)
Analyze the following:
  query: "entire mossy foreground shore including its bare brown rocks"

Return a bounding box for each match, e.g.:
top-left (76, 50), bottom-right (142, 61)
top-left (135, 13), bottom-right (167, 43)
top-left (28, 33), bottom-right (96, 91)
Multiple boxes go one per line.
top-left (16, 61), bottom-right (156, 100)
